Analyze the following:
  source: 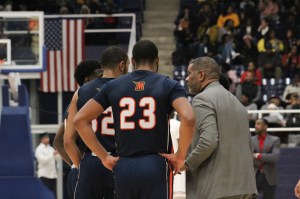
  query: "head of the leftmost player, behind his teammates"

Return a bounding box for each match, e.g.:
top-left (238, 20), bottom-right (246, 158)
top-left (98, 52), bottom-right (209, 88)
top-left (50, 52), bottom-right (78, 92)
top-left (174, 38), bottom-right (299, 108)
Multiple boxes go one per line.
top-left (74, 60), bottom-right (101, 86)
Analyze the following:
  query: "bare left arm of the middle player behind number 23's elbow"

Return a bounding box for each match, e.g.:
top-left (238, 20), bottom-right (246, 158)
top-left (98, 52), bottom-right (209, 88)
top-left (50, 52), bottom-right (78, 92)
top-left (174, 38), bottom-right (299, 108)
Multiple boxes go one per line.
top-left (64, 91), bottom-right (82, 168)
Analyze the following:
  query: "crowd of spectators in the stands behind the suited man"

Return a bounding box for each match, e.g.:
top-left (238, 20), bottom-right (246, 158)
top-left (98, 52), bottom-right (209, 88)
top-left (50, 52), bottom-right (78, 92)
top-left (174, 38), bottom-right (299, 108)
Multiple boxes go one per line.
top-left (172, 0), bottom-right (300, 143)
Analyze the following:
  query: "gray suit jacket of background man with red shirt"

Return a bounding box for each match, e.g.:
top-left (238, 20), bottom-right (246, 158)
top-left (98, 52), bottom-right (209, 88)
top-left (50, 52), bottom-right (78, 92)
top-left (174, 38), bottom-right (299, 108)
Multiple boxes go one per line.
top-left (252, 135), bottom-right (280, 185)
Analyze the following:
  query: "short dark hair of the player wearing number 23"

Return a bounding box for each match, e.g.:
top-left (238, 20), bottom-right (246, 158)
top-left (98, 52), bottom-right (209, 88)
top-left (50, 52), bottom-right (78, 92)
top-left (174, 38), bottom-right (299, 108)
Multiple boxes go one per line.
top-left (132, 40), bottom-right (158, 65)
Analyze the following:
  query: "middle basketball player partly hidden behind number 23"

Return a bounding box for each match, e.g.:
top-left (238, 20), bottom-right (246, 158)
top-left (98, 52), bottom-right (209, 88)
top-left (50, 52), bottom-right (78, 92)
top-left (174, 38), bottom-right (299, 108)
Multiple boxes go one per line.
top-left (65, 46), bottom-right (129, 199)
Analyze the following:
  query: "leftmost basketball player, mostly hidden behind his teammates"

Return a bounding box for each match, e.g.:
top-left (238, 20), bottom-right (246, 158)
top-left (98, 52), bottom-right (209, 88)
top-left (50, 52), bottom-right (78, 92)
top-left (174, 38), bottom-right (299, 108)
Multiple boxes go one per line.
top-left (54, 60), bottom-right (102, 198)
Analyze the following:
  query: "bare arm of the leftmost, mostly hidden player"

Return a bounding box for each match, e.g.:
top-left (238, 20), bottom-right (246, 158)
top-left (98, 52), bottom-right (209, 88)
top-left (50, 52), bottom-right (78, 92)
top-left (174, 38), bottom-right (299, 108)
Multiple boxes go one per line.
top-left (53, 123), bottom-right (72, 166)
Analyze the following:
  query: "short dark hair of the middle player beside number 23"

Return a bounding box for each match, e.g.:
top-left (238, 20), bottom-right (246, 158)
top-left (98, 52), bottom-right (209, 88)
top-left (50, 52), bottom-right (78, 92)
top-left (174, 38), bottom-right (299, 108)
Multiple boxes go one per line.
top-left (100, 46), bottom-right (128, 69)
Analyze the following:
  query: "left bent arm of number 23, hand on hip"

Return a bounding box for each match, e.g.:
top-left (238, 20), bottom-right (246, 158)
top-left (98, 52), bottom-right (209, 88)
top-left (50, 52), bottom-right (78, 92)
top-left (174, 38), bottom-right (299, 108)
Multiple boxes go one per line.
top-left (73, 99), bottom-right (118, 170)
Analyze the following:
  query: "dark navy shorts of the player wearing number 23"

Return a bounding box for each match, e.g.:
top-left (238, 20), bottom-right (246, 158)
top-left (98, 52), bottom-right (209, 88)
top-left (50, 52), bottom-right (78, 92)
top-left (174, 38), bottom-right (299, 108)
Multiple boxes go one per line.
top-left (113, 154), bottom-right (173, 199)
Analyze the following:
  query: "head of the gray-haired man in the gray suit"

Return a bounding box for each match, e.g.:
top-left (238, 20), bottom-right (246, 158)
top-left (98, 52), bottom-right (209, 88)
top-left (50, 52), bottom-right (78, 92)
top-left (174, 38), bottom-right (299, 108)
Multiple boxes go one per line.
top-left (186, 57), bottom-right (220, 94)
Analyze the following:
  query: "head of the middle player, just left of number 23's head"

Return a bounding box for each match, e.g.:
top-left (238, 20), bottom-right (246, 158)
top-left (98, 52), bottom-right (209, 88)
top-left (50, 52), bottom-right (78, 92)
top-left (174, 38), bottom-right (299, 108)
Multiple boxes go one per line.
top-left (100, 46), bottom-right (129, 74)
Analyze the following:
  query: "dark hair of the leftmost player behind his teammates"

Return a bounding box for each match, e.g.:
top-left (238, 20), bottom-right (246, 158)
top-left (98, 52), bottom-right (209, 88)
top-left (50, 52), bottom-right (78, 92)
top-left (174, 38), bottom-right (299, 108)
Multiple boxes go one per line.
top-left (74, 59), bottom-right (101, 86)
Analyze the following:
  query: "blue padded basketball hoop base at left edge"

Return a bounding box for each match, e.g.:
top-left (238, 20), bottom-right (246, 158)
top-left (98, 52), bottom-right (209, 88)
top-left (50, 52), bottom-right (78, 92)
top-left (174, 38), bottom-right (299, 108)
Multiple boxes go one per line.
top-left (0, 85), bottom-right (54, 199)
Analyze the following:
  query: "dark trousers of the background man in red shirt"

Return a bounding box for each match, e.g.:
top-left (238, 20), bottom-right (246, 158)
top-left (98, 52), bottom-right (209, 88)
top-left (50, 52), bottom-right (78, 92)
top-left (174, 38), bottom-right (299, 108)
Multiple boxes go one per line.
top-left (256, 171), bottom-right (276, 199)
